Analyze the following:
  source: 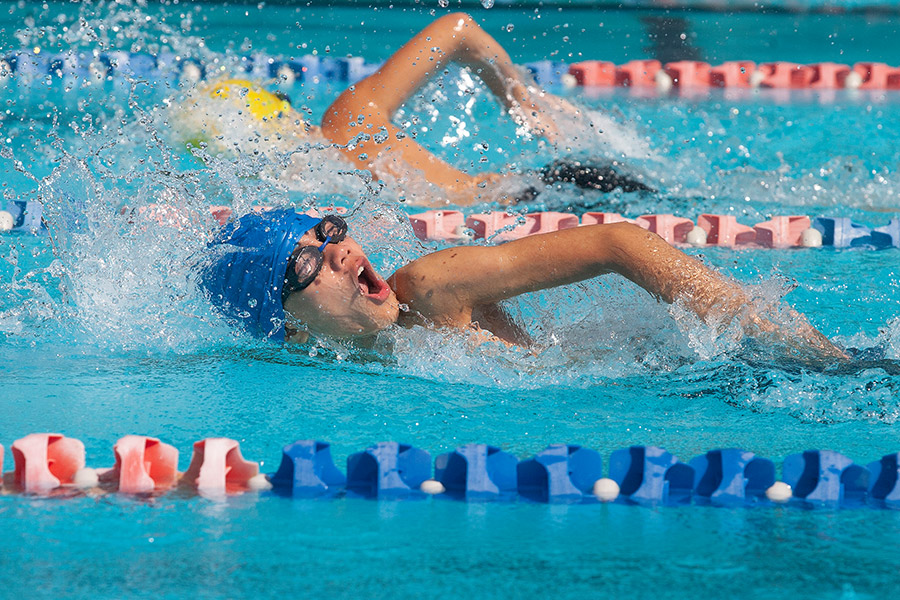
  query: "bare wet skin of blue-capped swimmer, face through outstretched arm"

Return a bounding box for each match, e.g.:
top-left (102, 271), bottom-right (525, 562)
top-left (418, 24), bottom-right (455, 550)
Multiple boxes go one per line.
top-left (285, 223), bottom-right (846, 360)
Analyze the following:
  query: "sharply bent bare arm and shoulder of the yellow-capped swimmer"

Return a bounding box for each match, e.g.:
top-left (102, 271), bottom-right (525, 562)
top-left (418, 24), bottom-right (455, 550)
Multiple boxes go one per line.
top-left (322, 13), bottom-right (556, 196)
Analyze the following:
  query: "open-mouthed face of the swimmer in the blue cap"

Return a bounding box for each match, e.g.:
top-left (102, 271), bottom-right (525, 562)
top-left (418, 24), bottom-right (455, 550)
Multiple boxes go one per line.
top-left (284, 231), bottom-right (399, 337)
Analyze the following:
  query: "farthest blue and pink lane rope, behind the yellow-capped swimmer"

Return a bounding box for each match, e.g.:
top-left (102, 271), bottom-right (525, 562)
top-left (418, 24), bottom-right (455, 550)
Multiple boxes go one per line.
top-left (0, 48), bottom-right (900, 93)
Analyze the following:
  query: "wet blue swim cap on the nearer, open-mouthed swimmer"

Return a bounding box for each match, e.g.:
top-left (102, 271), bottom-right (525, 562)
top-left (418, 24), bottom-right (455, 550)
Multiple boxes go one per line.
top-left (200, 209), bottom-right (321, 341)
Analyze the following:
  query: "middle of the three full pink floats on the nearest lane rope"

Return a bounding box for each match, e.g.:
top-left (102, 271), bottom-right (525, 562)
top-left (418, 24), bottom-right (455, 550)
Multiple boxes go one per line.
top-left (100, 435), bottom-right (178, 494)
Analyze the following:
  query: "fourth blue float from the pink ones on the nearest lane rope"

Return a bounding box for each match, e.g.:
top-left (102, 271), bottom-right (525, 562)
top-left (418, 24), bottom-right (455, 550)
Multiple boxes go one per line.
top-left (516, 444), bottom-right (603, 503)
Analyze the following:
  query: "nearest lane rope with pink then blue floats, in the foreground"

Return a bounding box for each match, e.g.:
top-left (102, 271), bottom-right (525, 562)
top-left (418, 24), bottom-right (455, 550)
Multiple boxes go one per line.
top-left (0, 433), bottom-right (900, 509)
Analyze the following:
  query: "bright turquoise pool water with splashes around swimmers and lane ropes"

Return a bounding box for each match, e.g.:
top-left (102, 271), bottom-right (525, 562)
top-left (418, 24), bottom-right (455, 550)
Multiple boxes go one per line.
top-left (0, 3), bottom-right (900, 598)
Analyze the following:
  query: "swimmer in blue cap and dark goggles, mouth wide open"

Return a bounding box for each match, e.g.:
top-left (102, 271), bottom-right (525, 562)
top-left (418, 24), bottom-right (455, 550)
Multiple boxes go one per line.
top-left (200, 209), bottom-right (846, 361)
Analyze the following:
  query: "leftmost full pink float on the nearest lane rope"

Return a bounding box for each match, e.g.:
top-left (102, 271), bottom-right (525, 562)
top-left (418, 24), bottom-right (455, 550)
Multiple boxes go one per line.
top-left (12, 433), bottom-right (84, 493)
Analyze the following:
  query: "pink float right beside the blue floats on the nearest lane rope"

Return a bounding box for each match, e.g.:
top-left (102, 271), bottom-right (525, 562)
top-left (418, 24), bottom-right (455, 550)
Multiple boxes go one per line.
top-left (181, 438), bottom-right (259, 493)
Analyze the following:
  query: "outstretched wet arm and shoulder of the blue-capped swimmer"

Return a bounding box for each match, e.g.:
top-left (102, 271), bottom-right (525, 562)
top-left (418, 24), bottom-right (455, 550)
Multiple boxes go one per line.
top-left (392, 223), bottom-right (845, 358)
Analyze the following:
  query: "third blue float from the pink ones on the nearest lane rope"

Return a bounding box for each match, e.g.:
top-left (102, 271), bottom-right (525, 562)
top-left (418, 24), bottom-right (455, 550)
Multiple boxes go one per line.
top-left (434, 444), bottom-right (519, 501)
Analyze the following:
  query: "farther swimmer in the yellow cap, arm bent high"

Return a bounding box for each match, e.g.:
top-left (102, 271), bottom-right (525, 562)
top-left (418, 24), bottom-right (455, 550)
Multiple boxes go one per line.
top-left (178, 13), bottom-right (653, 206)
